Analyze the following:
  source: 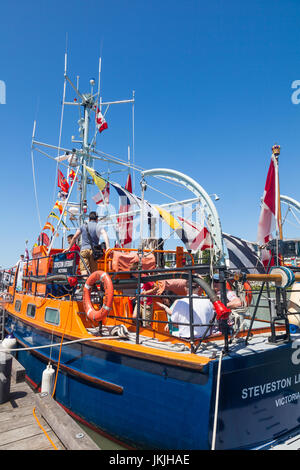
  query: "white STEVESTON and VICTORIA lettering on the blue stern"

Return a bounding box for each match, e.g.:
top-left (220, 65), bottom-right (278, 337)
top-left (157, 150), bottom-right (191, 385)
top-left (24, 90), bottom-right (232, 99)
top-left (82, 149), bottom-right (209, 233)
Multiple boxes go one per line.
top-left (242, 374), bottom-right (300, 406)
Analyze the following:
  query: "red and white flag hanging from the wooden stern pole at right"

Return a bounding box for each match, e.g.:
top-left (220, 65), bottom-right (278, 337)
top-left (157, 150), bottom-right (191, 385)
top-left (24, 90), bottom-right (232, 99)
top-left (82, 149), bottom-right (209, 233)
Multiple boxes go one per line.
top-left (257, 155), bottom-right (277, 266)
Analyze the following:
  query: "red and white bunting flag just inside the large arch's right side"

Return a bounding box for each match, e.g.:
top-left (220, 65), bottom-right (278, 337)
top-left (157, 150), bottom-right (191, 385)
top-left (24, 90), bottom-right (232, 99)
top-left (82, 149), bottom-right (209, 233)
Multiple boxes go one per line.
top-left (176, 217), bottom-right (213, 253)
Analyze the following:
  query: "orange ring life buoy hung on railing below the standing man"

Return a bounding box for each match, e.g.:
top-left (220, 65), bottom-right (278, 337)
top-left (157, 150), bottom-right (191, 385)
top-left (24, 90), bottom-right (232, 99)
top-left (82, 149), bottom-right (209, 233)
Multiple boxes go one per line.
top-left (83, 271), bottom-right (114, 321)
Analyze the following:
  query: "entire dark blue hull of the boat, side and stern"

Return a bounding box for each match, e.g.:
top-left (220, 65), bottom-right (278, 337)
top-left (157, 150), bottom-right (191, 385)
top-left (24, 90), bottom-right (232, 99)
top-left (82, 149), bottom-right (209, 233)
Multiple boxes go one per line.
top-left (7, 316), bottom-right (300, 450)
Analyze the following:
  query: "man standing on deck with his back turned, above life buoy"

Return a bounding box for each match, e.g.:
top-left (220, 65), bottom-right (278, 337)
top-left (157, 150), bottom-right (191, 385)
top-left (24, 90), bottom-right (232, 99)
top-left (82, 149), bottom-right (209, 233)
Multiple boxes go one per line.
top-left (65, 211), bottom-right (109, 275)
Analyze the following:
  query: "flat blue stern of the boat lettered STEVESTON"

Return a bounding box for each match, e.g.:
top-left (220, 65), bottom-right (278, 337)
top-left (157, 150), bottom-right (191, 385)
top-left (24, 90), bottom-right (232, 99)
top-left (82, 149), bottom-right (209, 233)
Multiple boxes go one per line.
top-left (216, 342), bottom-right (300, 449)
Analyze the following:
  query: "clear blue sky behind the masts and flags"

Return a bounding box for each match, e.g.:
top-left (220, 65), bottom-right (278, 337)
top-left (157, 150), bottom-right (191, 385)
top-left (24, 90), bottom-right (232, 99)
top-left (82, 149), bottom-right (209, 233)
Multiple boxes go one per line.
top-left (0, 0), bottom-right (300, 266)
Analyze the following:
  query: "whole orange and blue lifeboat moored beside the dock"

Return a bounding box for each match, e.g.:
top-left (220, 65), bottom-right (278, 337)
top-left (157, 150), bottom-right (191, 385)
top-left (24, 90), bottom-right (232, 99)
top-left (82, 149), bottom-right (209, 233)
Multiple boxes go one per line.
top-left (2, 58), bottom-right (300, 450)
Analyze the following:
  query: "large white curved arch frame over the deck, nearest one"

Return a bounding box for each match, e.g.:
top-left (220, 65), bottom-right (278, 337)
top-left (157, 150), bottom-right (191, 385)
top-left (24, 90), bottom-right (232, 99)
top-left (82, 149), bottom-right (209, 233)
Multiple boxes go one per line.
top-left (141, 168), bottom-right (225, 266)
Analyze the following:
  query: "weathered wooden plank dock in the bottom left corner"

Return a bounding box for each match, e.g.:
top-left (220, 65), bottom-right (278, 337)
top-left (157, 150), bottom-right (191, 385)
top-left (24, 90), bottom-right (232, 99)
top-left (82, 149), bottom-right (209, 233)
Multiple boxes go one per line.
top-left (0, 358), bottom-right (100, 451)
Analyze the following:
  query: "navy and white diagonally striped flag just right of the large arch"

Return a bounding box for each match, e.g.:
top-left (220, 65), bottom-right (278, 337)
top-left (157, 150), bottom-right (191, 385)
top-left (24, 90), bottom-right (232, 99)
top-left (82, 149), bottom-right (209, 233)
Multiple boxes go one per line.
top-left (223, 233), bottom-right (265, 274)
